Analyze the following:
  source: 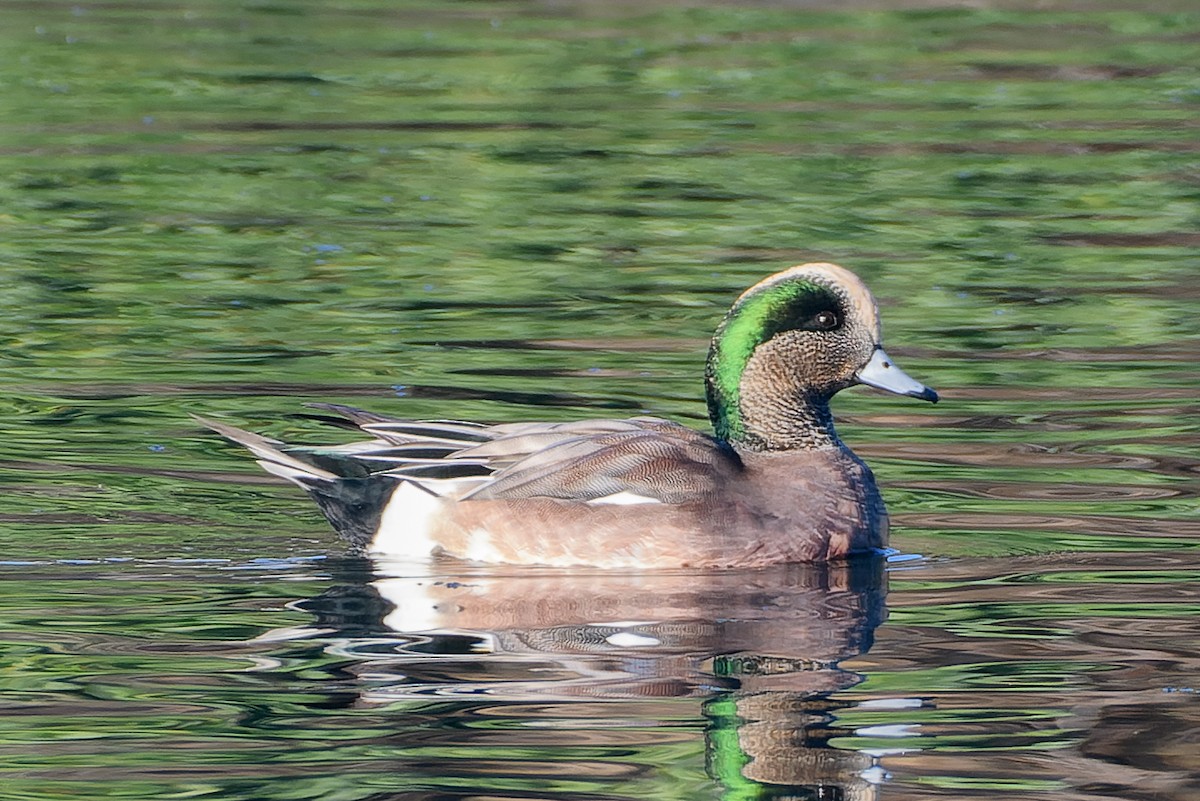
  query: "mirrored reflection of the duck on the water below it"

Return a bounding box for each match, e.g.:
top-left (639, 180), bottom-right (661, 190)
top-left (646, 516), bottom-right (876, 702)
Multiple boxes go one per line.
top-left (274, 559), bottom-right (887, 799)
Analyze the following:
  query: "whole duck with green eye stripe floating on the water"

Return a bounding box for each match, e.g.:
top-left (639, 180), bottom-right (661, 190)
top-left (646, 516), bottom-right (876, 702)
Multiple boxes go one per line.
top-left (196, 263), bottom-right (938, 570)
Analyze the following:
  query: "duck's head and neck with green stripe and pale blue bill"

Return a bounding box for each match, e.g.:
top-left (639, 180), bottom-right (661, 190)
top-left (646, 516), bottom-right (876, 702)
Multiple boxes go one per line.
top-left (706, 264), bottom-right (937, 450)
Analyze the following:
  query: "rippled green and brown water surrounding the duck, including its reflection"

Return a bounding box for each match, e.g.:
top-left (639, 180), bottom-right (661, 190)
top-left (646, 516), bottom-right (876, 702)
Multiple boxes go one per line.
top-left (0, 0), bottom-right (1200, 801)
